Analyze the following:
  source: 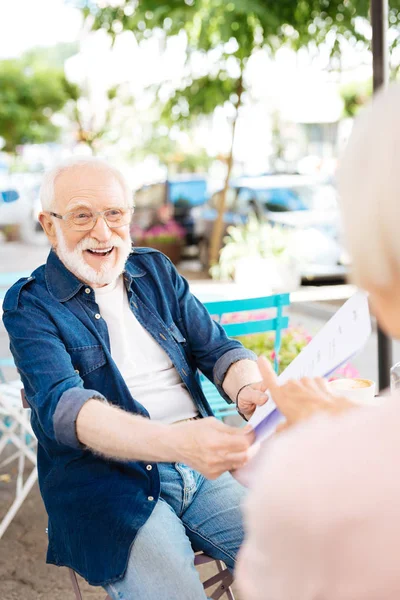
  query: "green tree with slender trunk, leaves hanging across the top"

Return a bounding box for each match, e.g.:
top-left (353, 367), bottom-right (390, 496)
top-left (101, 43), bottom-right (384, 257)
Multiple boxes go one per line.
top-left (79, 0), bottom-right (400, 264)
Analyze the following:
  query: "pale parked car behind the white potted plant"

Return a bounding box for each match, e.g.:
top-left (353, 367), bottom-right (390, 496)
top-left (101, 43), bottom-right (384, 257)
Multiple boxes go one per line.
top-left (195, 175), bottom-right (346, 281)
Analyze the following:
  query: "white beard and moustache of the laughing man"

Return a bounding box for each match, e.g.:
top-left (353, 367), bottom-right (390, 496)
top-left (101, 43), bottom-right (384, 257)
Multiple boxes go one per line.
top-left (56, 223), bottom-right (132, 285)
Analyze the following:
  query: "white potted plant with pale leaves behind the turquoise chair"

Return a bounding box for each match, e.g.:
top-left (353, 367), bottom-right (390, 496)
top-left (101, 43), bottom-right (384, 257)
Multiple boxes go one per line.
top-left (210, 215), bottom-right (300, 293)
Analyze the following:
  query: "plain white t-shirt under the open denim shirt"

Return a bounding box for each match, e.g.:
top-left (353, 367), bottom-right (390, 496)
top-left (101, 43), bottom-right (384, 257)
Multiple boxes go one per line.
top-left (95, 275), bottom-right (198, 423)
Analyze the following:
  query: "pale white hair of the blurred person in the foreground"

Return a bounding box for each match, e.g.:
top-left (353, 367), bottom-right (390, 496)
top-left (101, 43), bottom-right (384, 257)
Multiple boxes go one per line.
top-left (338, 84), bottom-right (400, 287)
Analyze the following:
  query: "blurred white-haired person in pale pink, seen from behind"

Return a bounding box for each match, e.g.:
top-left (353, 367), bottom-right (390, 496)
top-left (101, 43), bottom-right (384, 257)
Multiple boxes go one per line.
top-left (236, 85), bottom-right (400, 600)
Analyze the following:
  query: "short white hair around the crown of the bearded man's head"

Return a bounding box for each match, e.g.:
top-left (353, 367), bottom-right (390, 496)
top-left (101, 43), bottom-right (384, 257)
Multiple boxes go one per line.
top-left (40, 156), bottom-right (133, 210)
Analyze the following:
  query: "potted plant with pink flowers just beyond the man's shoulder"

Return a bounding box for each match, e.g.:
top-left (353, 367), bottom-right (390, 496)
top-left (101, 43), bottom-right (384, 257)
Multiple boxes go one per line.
top-left (131, 207), bottom-right (185, 264)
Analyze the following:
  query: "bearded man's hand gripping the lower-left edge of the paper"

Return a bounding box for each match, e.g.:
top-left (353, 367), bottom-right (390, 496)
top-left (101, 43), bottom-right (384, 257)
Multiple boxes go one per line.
top-left (171, 417), bottom-right (254, 479)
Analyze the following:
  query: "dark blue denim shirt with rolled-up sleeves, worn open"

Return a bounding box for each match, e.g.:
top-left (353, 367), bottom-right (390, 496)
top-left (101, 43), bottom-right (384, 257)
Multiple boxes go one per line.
top-left (3, 248), bottom-right (256, 585)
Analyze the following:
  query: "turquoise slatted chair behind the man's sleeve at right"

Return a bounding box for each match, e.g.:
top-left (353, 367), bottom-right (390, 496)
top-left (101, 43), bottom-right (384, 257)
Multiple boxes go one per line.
top-left (200, 294), bottom-right (290, 420)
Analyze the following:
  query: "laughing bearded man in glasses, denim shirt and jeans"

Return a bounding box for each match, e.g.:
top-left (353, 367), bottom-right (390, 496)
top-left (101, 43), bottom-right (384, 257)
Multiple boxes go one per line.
top-left (3, 159), bottom-right (266, 600)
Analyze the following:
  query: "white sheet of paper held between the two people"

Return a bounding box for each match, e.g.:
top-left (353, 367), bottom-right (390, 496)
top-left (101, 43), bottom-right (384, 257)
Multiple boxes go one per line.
top-left (249, 292), bottom-right (371, 441)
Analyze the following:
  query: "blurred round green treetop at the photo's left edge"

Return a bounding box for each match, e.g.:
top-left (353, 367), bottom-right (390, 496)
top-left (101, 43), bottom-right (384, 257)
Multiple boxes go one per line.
top-left (0, 59), bottom-right (78, 153)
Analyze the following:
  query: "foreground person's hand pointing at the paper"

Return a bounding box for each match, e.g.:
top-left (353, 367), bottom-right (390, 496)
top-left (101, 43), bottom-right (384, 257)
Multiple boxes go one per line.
top-left (258, 356), bottom-right (355, 430)
